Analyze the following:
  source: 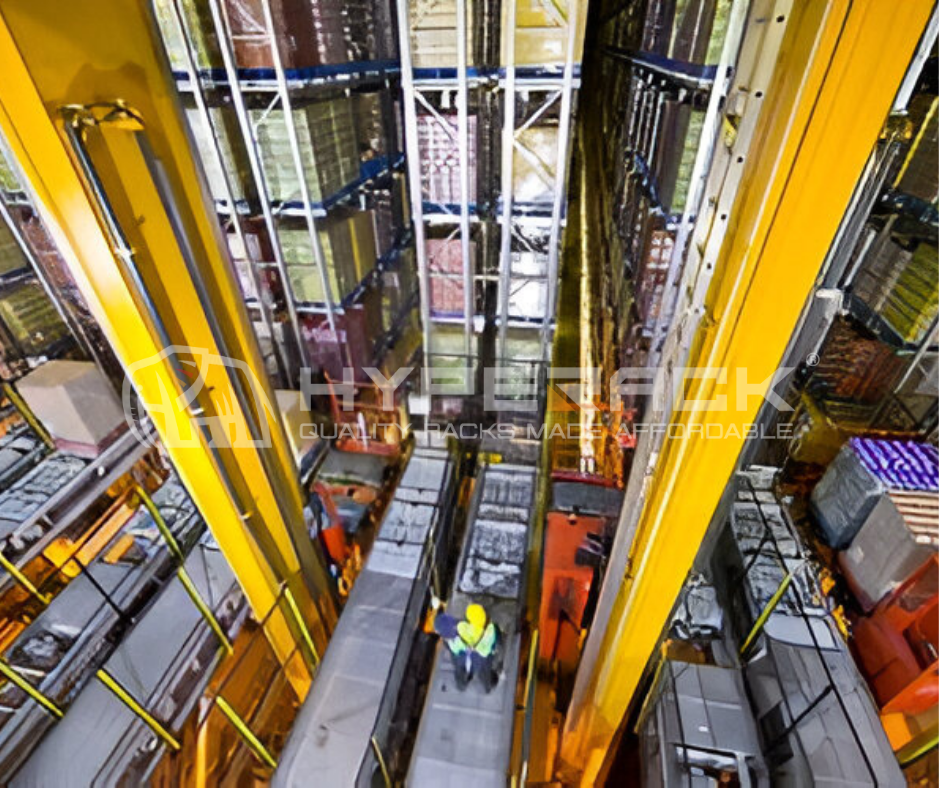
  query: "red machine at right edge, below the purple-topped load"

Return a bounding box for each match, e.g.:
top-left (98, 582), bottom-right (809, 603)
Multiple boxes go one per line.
top-left (851, 555), bottom-right (940, 715)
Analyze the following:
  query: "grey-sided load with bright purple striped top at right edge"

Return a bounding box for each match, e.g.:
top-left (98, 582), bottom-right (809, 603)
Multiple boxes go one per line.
top-left (812, 438), bottom-right (940, 550)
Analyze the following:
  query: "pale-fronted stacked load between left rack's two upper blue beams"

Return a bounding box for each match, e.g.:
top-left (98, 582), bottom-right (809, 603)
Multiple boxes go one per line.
top-left (251, 99), bottom-right (359, 203)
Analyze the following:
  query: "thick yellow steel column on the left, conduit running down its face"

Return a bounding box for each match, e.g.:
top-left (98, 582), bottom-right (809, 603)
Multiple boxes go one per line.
top-left (0, 0), bottom-right (335, 680)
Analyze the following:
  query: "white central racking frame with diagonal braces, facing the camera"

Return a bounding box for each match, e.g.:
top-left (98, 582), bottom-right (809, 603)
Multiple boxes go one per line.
top-left (397, 0), bottom-right (585, 422)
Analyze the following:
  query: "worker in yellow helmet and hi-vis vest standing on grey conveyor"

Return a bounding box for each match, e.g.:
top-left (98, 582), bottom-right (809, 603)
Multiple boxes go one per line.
top-left (434, 603), bottom-right (500, 692)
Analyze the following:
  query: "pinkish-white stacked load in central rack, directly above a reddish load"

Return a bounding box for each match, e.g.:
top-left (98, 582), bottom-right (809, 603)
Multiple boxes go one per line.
top-left (418, 114), bottom-right (477, 205)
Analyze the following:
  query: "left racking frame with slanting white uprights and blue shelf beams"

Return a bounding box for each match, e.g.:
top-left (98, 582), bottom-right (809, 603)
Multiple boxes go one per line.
top-left (158, 0), bottom-right (410, 387)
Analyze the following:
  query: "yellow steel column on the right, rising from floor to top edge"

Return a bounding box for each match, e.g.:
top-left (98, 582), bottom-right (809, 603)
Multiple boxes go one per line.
top-left (562, 0), bottom-right (932, 785)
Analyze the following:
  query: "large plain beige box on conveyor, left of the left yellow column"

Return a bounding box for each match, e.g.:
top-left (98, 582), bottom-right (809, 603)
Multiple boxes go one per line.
top-left (17, 360), bottom-right (125, 449)
